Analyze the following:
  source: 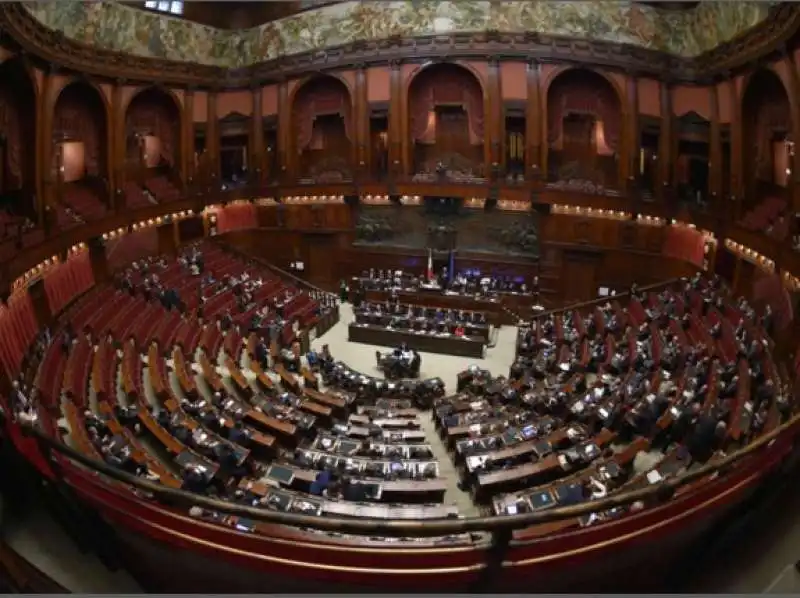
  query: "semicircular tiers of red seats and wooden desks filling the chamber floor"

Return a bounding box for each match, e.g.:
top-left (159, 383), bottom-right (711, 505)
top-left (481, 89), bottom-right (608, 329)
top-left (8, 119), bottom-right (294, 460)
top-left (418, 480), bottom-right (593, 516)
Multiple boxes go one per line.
top-left (12, 243), bottom-right (795, 546)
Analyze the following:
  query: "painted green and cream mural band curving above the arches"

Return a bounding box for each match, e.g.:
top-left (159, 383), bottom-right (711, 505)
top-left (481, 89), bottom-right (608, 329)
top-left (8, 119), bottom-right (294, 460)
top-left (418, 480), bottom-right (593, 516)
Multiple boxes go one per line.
top-left (24, 0), bottom-right (776, 68)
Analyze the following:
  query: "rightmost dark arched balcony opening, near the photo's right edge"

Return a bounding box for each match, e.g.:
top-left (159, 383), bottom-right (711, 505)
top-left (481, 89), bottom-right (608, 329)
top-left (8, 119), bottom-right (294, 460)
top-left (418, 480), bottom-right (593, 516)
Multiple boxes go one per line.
top-left (742, 69), bottom-right (794, 213)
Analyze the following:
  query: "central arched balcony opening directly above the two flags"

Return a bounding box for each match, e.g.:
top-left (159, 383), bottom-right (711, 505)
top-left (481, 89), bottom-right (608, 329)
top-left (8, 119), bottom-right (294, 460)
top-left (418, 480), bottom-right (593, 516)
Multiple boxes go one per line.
top-left (408, 64), bottom-right (485, 180)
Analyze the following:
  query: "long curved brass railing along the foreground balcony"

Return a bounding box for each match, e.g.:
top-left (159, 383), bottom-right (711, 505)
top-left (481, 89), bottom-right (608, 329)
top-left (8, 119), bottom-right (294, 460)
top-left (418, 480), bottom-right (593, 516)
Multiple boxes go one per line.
top-left (17, 414), bottom-right (800, 537)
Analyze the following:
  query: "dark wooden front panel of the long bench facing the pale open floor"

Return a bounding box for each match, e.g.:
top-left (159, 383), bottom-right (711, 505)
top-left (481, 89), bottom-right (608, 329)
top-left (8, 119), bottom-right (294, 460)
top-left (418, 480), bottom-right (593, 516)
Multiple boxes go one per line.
top-left (348, 324), bottom-right (484, 359)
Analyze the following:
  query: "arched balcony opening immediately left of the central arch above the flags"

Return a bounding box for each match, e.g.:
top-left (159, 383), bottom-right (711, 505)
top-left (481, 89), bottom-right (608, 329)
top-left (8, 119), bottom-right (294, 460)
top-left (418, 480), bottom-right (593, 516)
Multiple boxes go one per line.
top-left (292, 76), bottom-right (355, 183)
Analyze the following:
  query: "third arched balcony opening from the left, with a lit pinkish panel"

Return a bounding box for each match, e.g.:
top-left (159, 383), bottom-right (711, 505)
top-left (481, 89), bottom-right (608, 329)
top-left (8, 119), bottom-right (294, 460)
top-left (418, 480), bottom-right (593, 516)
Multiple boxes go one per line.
top-left (123, 87), bottom-right (181, 209)
